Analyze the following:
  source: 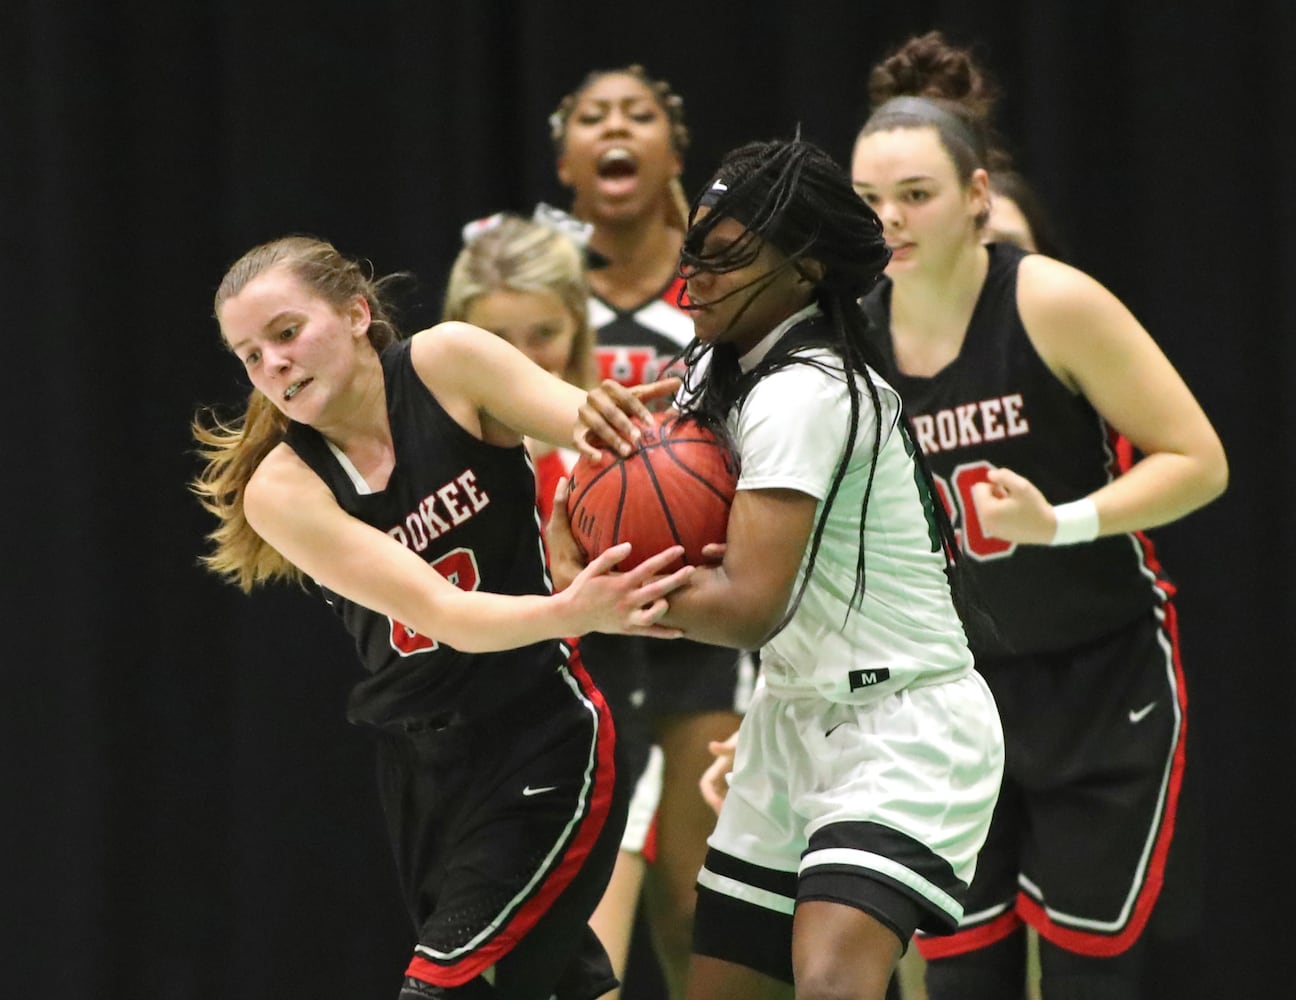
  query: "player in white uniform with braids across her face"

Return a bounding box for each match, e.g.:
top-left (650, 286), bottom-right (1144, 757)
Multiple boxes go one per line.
top-left (551, 140), bottom-right (1003, 1000)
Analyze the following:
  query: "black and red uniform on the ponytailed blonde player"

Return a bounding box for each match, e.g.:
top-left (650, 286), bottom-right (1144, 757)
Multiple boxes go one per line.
top-left (288, 342), bottom-right (626, 1000)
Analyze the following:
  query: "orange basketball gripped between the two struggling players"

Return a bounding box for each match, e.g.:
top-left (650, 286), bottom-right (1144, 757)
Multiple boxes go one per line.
top-left (568, 412), bottom-right (737, 570)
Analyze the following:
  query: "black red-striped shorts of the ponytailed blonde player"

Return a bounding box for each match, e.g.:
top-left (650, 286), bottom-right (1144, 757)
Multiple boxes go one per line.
top-left (378, 659), bottom-right (626, 1000)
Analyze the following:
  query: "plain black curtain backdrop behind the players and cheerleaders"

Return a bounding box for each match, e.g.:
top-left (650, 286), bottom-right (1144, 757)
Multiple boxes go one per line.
top-left (0, 0), bottom-right (1296, 1000)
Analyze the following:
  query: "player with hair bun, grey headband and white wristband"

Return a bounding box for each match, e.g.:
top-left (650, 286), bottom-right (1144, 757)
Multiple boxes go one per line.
top-left (851, 32), bottom-right (1227, 1000)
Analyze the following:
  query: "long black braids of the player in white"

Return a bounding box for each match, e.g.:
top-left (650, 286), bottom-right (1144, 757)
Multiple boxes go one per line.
top-left (680, 137), bottom-right (956, 631)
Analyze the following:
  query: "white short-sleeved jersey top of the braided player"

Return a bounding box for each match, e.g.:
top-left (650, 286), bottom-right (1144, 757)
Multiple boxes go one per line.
top-left (728, 306), bottom-right (972, 705)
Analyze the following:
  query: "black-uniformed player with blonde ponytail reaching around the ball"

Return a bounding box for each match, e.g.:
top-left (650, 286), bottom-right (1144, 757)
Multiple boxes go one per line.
top-left (193, 237), bottom-right (689, 1000)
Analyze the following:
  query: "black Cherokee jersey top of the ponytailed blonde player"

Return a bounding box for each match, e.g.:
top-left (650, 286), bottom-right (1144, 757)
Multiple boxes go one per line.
top-left (286, 341), bottom-right (566, 725)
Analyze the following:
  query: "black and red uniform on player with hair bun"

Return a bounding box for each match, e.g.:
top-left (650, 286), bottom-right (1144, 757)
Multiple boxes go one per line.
top-left (863, 244), bottom-right (1187, 968)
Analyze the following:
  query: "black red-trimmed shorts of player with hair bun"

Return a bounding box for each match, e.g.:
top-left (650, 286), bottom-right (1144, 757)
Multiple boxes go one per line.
top-left (918, 604), bottom-right (1187, 960)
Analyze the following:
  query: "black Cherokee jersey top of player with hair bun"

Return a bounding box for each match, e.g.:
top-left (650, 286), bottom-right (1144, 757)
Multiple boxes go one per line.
top-left (862, 244), bottom-right (1173, 657)
